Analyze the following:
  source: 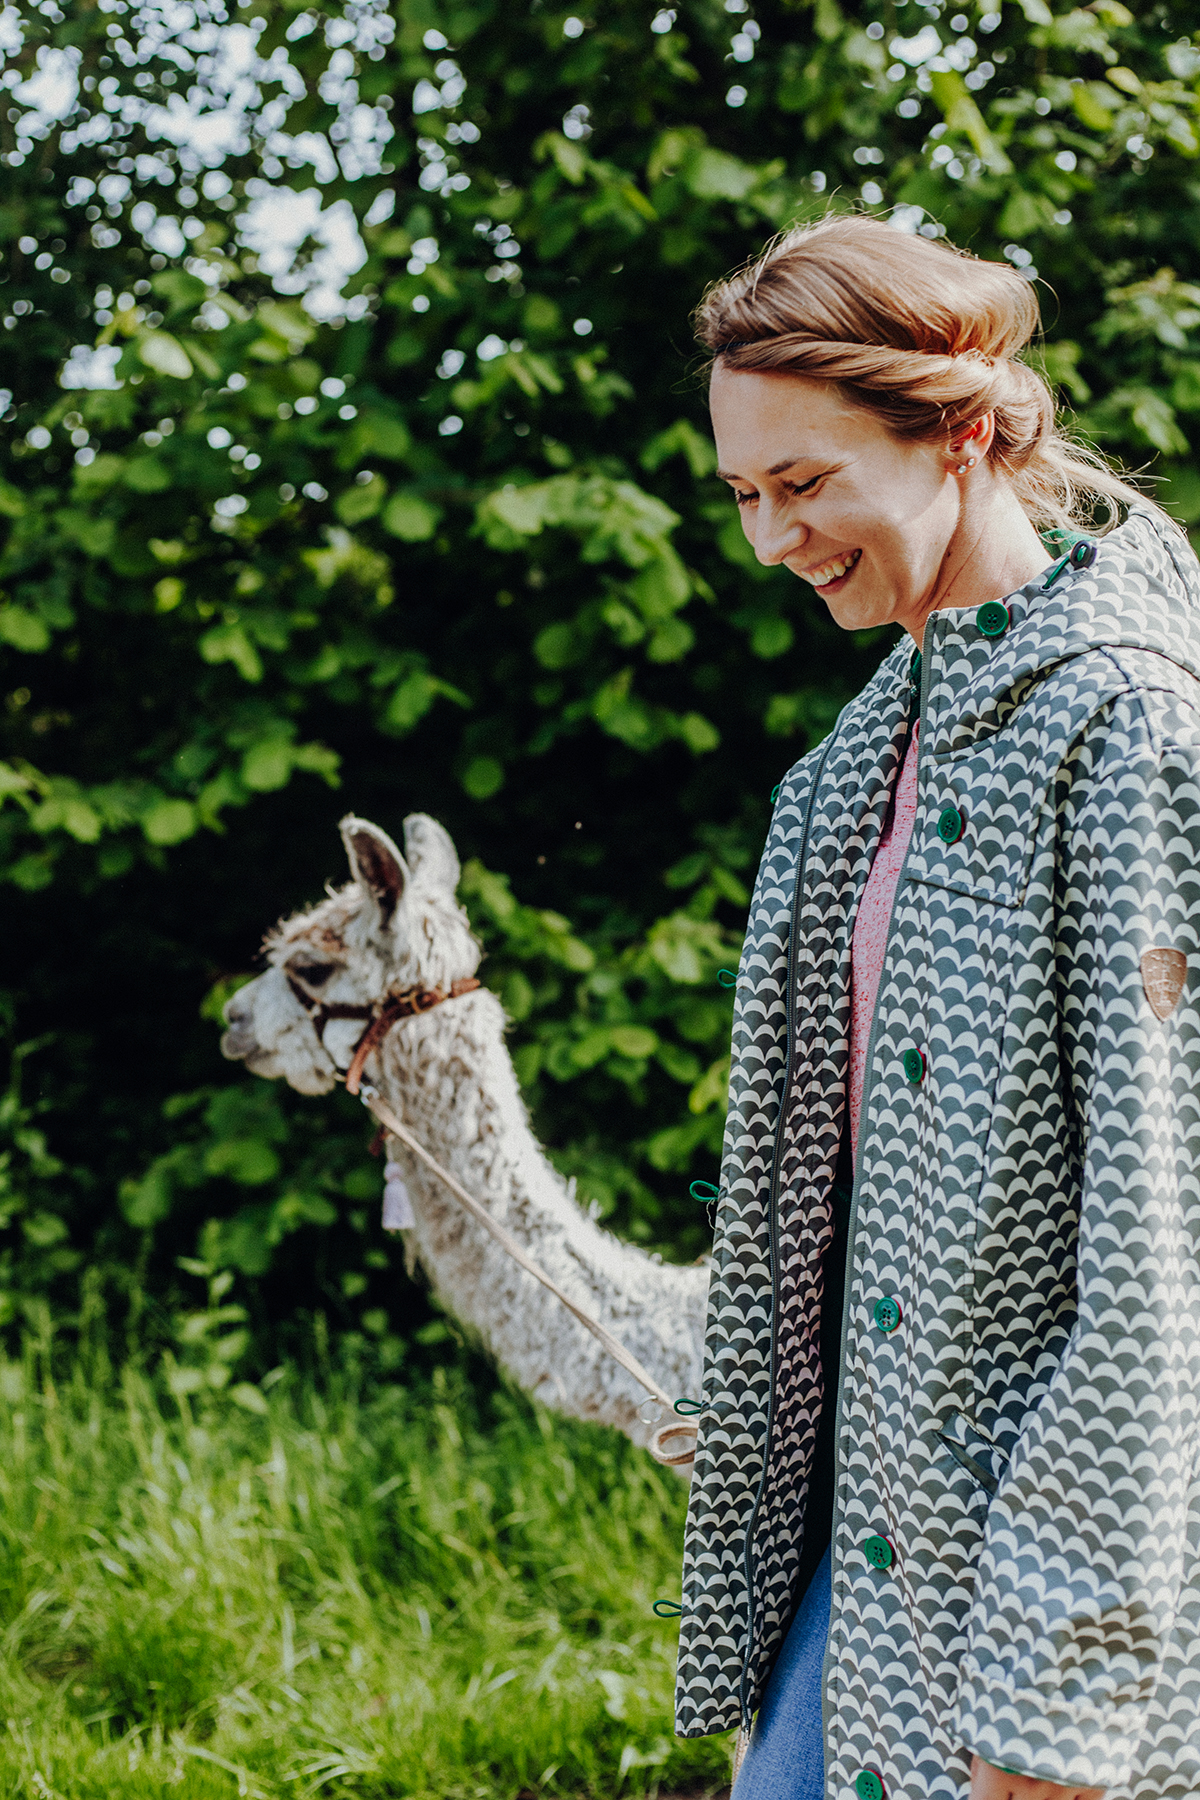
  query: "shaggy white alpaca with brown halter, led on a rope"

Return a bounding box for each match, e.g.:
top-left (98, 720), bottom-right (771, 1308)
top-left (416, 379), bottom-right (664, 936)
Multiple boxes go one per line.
top-left (221, 814), bottom-right (709, 1444)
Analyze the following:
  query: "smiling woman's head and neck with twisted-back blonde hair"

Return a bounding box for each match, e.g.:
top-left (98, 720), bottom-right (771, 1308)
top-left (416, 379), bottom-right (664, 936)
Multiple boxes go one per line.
top-left (696, 218), bottom-right (1144, 643)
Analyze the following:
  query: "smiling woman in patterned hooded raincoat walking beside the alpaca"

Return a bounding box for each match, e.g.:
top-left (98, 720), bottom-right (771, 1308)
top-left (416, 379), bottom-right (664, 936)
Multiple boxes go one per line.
top-left (678, 218), bottom-right (1200, 1800)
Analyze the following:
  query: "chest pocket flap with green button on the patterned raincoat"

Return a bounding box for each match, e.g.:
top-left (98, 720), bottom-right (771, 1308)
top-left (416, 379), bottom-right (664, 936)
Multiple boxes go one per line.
top-left (905, 743), bottom-right (1045, 907)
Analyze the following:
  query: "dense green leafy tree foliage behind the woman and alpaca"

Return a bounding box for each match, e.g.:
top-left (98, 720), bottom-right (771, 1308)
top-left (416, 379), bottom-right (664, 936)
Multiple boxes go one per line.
top-left (0, 0), bottom-right (1200, 1353)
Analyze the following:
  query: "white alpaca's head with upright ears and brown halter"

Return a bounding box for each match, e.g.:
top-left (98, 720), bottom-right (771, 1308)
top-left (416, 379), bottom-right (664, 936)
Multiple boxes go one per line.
top-left (221, 812), bottom-right (480, 1094)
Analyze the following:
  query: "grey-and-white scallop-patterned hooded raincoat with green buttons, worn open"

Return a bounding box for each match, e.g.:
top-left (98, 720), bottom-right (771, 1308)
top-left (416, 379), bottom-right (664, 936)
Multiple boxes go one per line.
top-left (676, 508), bottom-right (1200, 1800)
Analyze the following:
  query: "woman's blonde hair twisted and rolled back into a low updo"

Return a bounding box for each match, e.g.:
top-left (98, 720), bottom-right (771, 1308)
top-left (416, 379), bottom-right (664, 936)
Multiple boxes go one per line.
top-left (694, 214), bottom-right (1173, 531)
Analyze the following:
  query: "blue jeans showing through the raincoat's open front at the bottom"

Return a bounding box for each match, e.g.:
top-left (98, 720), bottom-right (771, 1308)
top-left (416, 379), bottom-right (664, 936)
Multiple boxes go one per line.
top-left (732, 1550), bottom-right (831, 1800)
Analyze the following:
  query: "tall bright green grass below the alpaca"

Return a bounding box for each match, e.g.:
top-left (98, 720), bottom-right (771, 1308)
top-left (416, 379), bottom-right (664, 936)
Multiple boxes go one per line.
top-left (0, 1324), bottom-right (729, 1800)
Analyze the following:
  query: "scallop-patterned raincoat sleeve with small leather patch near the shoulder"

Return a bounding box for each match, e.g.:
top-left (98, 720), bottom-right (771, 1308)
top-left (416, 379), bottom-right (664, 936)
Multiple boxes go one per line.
top-left (957, 697), bottom-right (1200, 1787)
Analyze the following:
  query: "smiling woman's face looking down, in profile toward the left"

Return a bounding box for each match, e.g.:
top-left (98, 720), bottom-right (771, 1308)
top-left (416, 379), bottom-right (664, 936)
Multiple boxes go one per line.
top-left (709, 362), bottom-right (986, 641)
